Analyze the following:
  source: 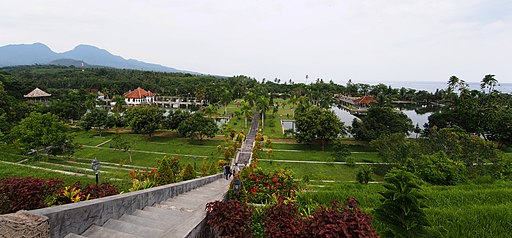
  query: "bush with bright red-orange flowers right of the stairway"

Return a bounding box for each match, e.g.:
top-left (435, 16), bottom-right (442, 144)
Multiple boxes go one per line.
top-left (241, 167), bottom-right (297, 203)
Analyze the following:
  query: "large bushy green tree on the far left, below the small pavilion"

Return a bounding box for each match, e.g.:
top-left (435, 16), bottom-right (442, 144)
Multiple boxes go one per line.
top-left (10, 112), bottom-right (74, 154)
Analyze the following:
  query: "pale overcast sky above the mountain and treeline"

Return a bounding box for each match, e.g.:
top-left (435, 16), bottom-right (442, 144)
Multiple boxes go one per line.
top-left (0, 0), bottom-right (512, 84)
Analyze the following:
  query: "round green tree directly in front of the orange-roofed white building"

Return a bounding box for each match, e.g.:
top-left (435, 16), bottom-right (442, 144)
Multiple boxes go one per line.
top-left (126, 106), bottom-right (163, 137)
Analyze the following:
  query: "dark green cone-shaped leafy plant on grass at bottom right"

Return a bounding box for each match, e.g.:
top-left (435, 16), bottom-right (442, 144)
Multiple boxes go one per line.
top-left (375, 169), bottom-right (432, 237)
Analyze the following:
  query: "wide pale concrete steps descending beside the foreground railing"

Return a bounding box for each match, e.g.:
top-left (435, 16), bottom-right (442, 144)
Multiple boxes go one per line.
top-left (65, 179), bottom-right (229, 238)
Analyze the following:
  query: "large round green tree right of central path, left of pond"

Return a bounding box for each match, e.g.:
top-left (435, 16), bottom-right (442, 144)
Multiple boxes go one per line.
top-left (295, 106), bottom-right (345, 150)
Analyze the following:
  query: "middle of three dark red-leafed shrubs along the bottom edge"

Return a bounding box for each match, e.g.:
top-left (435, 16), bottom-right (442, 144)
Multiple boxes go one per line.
top-left (263, 203), bottom-right (304, 237)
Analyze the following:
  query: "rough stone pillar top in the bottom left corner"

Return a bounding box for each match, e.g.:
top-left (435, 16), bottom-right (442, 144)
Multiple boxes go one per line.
top-left (0, 211), bottom-right (50, 238)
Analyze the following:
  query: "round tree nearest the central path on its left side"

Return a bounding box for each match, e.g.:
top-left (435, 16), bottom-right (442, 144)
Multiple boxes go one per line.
top-left (178, 113), bottom-right (219, 140)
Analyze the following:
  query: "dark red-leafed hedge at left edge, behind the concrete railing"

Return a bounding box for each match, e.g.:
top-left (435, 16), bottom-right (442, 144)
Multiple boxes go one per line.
top-left (0, 177), bottom-right (63, 214)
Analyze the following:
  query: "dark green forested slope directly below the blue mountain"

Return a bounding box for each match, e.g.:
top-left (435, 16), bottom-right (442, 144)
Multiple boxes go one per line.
top-left (0, 65), bottom-right (257, 101)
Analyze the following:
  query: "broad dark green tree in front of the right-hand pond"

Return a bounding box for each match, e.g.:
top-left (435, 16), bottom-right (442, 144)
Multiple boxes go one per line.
top-left (352, 107), bottom-right (414, 141)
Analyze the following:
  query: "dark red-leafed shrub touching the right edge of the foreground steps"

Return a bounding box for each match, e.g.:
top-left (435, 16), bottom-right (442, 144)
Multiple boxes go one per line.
top-left (206, 200), bottom-right (252, 238)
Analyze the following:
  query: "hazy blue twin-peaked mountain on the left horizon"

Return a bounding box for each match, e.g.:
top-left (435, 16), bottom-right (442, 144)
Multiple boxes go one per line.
top-left (0, 43), bottom-right (198, 74)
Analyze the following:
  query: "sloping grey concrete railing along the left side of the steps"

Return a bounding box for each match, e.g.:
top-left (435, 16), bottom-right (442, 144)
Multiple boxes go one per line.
top-left (28, 174), bottom-right (222, 237)
